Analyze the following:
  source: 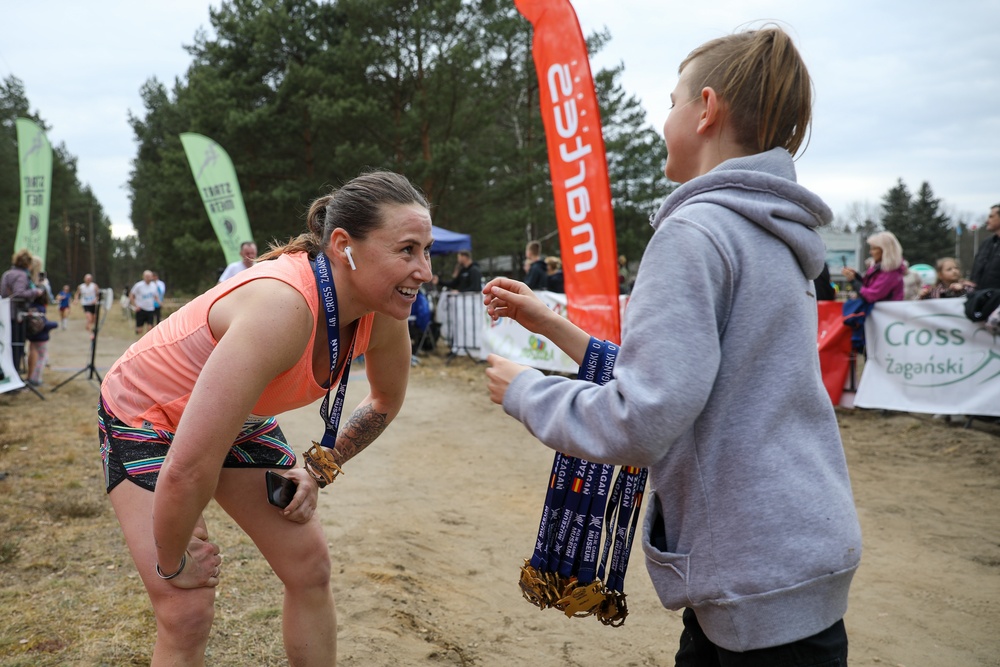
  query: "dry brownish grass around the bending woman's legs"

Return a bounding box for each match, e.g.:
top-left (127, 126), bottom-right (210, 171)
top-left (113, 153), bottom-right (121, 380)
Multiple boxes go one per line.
top-left (0, 310), bottom-right (285, 667)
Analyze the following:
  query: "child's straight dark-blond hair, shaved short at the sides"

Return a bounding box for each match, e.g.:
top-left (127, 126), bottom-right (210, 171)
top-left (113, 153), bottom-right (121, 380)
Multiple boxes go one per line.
top-left (679, 26), bottom-right (812, 155)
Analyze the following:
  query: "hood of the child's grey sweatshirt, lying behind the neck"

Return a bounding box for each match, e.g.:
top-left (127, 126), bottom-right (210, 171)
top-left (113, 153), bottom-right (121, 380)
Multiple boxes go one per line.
top-left (650, 148), bottom-right (833, 280)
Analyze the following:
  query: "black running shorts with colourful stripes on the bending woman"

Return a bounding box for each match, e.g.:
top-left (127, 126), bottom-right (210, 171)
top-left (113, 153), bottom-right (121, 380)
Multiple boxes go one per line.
top-left (97, 399), bottom-right (295, 493)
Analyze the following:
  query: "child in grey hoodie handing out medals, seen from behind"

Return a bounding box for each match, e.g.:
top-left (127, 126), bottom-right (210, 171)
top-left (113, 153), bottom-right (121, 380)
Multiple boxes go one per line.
top-left (483, 27), bottom-right (861, 667)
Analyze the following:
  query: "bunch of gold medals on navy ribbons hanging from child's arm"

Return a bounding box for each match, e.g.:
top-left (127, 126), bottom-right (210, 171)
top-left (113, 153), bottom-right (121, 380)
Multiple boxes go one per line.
top-left (520, 339), bottom-right (647, 626)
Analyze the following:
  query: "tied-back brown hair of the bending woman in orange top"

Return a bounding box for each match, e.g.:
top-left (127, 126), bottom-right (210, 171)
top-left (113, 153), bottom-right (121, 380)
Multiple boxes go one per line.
top-left (258, 171), bottom-right (430, 261)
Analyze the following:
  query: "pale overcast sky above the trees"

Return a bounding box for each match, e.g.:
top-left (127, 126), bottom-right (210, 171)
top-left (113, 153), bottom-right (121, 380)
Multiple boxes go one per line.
top-left (0, 0), bottom-right (1000, 236)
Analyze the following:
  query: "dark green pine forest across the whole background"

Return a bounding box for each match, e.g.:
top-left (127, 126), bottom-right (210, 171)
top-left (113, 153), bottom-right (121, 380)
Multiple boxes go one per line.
top-left (0, 0), bottom-right (981, 296)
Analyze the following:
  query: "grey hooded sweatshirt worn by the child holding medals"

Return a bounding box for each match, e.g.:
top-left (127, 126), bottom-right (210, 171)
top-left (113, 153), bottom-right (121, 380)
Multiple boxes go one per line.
top-left (503, 149), bottom-right (861, 651)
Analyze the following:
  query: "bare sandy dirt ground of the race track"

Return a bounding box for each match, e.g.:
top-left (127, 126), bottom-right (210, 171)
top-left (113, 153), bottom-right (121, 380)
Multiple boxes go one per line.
top-left (0, 312), bottom-right (1000, 667)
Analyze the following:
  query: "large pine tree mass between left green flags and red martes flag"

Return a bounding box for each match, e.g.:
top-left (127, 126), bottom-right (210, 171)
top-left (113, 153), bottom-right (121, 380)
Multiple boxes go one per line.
top-left (124, 0), bottom-right (555, 291)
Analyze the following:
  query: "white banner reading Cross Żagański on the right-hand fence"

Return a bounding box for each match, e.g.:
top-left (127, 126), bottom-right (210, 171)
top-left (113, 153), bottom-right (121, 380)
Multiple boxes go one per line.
top-left (854, 299), bottom-right (1000, 417)
